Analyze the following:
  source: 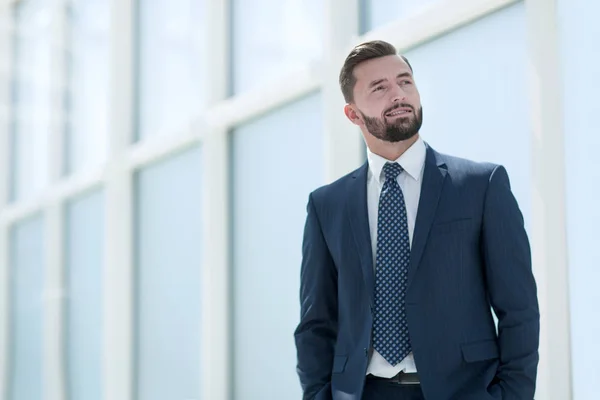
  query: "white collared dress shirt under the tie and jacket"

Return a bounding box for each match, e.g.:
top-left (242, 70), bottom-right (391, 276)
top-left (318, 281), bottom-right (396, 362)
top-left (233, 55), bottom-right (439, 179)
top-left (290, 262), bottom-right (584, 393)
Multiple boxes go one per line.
top-left (367, 137), bottom-right (426, 378)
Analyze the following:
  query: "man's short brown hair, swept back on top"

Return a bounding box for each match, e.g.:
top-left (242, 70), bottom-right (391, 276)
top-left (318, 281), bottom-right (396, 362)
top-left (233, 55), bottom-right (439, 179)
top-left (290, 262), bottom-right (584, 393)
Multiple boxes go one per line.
top-left (340, 40), bottom-right (412, 103)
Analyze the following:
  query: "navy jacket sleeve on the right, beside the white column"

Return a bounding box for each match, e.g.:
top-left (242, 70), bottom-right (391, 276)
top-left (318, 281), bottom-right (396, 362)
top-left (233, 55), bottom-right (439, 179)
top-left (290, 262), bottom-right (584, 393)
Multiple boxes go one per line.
top-left (482, 166), bottom-right (540, 400)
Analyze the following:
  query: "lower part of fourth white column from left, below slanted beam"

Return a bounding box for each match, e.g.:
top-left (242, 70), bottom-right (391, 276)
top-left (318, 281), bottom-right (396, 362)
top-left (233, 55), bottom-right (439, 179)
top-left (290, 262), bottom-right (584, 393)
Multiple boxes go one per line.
top-left (201, 131), bottom-right (233, 400)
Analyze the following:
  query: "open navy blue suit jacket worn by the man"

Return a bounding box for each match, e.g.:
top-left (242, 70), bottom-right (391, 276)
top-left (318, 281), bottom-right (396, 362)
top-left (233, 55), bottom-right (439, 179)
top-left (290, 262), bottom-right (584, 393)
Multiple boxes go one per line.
top-left (294, 146), bottom-right (539, 400)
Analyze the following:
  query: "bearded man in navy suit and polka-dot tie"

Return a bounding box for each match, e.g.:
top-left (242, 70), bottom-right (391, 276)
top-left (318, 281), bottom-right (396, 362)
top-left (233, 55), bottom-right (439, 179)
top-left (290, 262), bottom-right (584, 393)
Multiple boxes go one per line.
top-left (294, 41), bottom-right (539, 400)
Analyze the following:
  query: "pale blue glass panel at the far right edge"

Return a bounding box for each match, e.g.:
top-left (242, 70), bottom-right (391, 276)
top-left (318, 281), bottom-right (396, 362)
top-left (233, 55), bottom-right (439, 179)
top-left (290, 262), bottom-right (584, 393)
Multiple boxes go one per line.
top-left (557, 0), bottom-right (600, 399)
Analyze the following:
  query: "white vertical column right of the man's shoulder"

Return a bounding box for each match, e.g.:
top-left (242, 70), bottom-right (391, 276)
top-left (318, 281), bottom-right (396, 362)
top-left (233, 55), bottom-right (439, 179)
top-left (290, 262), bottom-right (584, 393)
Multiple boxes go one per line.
top-left (526, 0), bottom-right (572, 400)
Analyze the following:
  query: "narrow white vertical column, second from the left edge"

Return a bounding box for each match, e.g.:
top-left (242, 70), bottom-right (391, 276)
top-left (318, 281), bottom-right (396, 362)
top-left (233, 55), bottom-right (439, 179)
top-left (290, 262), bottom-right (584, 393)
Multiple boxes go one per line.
top-left (42, 0), bottom-right (67, 400)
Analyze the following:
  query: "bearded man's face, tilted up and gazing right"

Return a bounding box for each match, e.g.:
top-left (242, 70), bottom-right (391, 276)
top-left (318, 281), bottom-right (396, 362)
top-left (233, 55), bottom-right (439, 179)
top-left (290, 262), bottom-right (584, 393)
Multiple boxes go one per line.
top-left (345, 55), bottom-right (423, 142)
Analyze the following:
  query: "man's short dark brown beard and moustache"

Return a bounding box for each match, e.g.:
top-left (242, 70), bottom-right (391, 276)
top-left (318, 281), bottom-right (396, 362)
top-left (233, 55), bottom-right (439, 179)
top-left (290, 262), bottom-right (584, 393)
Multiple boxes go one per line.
top-left (359, 104), bottom-right (423, 142)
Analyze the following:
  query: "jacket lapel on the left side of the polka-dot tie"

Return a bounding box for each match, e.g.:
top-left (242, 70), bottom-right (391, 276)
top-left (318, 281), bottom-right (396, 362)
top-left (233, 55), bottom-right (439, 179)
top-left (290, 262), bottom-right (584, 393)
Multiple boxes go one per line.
top-left (347, 163), bottom-right (374, 304)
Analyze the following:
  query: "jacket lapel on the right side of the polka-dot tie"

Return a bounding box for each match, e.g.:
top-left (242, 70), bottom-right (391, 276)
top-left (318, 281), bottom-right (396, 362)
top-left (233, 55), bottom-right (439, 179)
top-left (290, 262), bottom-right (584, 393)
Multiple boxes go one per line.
top-left (408, 146), bottom-right (448, 286)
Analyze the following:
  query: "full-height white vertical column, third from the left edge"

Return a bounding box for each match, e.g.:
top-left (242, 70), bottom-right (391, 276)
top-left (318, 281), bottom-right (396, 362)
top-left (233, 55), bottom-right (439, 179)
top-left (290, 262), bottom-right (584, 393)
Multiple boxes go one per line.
top-left (102, 0), bottom-right (135, 400)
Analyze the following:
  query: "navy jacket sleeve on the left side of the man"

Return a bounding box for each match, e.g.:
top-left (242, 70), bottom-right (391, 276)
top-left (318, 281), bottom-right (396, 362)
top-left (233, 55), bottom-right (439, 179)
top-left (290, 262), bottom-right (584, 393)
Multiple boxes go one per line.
top-left (294, 196), bottom-right (337, 400)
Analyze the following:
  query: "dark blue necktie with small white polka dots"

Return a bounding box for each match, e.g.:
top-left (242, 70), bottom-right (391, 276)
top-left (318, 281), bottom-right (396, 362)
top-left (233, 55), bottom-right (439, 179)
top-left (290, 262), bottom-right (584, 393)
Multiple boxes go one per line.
top-left (373, 163), bottom-right (411, 365)
